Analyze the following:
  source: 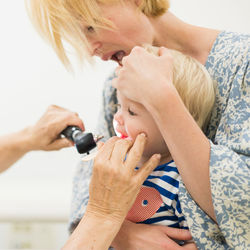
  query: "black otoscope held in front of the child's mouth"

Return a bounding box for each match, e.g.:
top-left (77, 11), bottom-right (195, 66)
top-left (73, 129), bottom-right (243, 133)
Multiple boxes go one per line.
top-left (61, 126), bottom-right (103, 154)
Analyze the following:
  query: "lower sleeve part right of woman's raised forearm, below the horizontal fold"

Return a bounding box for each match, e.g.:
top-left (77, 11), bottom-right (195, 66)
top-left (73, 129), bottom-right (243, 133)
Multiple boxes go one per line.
top-left (210, 143), bottom-right (250, 249)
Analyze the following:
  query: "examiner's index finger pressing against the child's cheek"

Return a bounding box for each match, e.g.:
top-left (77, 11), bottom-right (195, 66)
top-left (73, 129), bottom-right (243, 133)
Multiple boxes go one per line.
top-left (125, 133), bottom-right (147, 170)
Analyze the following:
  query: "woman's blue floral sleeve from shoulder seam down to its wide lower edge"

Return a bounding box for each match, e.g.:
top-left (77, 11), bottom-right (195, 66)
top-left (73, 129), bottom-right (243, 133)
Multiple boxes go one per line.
top-left (210, 55), bottom-right (250, 249)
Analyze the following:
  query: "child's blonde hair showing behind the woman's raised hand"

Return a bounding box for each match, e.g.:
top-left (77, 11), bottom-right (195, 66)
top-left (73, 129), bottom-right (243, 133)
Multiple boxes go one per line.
top-left (144, 45), bottom-right (215, 131)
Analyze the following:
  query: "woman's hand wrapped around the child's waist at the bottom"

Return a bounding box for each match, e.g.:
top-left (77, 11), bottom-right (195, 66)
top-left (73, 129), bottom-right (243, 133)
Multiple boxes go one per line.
top-left (112, 220), bottom-right (197, 250)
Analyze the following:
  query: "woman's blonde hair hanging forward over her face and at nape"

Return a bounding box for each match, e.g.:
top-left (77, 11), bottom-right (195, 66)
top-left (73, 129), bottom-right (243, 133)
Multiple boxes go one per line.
top-left (26, 0), bottom-right (169, 66)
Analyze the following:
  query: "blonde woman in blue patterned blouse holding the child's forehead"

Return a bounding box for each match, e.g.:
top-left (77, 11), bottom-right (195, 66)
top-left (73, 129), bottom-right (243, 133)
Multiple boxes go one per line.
top-left (26, 0), bottom-right (250, 249)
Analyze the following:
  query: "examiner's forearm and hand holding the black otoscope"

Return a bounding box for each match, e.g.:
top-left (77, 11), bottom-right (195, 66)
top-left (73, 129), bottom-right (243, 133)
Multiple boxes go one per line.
top-left (0, 105), bottom-right (84, 172)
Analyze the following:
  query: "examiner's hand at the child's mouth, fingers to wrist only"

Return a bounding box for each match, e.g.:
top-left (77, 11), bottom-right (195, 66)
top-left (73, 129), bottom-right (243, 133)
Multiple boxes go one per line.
top-left (86, 134), bottom-right (160, 222)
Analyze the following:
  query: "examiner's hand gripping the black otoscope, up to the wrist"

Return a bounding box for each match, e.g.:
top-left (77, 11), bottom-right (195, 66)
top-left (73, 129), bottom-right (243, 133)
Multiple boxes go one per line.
top-left (26, 105), bottom-right (84, 151)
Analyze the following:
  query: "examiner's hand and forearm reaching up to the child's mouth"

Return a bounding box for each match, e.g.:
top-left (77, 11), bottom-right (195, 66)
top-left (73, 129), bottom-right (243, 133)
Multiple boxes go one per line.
top-left (63, 134), bottom-right (160, 250)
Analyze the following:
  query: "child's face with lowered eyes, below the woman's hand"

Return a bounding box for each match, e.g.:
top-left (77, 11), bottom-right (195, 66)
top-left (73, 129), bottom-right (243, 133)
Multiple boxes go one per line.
top-left (114, 91), bottom-right (169, 158)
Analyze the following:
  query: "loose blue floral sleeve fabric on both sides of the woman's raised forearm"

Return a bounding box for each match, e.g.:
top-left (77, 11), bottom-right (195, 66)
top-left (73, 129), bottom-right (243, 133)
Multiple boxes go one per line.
top-left (179, 141), bottom-right (250, 249)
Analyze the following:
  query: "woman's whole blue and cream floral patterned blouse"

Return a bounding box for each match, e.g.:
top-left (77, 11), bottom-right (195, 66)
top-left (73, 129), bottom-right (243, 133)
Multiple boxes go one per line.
top-left (70, 32), bottom-right (250, 249)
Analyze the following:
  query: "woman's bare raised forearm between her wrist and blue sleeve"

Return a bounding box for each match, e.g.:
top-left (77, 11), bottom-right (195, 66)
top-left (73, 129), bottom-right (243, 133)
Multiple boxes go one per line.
top-left (147, 88), bottom-right (216, 221)
